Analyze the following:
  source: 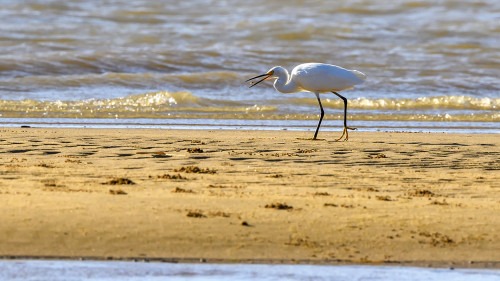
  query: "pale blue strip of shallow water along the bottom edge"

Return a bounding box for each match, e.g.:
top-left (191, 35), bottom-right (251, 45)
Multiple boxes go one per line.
top-left (0, 261), bottom-right (500, 281)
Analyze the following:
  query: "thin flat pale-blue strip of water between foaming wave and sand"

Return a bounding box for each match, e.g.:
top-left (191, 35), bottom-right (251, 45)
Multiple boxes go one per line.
top-left (0, 116), bottom-right (500, 134)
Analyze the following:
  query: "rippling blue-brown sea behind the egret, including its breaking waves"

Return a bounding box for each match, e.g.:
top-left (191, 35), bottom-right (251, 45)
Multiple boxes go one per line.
top-left (0, 0), bottom-right (500, 133)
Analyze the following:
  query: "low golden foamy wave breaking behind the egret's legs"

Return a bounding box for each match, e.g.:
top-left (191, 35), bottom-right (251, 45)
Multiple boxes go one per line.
top-left (0, 91), bottom-right (500, 122)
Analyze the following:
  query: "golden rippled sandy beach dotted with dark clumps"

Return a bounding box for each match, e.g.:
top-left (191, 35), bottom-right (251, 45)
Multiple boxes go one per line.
top-left (0, 128), bottom-right (500, 267)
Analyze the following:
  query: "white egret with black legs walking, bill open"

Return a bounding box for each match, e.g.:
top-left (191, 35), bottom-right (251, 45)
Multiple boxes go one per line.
top-left (245, 63), bottom-right (366, 141)
